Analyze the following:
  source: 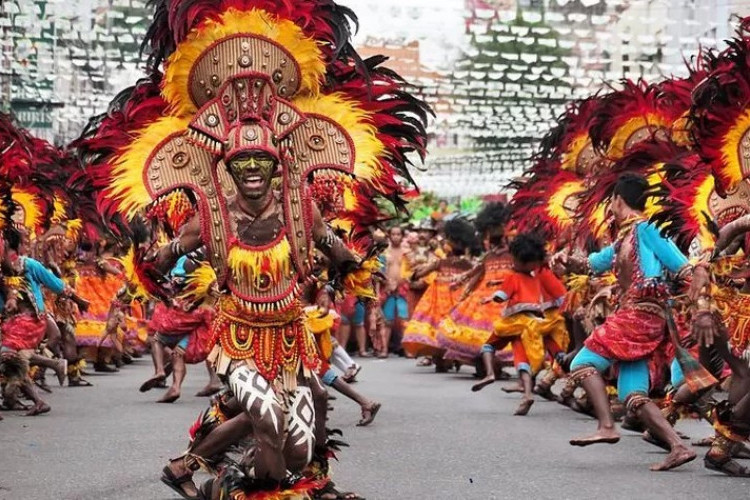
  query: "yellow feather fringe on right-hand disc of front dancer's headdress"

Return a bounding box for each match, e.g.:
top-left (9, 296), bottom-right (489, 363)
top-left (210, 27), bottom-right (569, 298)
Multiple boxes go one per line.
top-left (294, 92), bottom-right (385, 187)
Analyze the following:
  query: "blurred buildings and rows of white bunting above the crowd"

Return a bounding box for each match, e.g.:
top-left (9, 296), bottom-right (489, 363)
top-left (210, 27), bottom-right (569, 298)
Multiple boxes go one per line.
top-left (0, 0), bottom-right (750, 199)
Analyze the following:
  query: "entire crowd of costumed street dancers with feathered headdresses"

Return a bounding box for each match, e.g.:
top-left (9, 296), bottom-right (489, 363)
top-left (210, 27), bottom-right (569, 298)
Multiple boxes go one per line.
top-left (0, 0), bottom-right (750, 500)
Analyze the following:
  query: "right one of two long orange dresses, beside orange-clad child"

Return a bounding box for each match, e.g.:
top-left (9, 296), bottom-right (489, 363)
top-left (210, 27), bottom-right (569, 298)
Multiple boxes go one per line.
top-left (437, 251), bottom-right (513, 364)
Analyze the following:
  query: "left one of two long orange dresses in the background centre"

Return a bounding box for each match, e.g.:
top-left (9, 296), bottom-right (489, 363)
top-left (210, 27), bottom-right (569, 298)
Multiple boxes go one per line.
top-left (401, 257), bottom-right (471, 356)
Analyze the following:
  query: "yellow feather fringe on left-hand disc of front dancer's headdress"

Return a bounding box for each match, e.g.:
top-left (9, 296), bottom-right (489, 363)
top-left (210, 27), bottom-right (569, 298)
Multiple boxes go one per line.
top-left (110, 116), bottom-right (189, 218)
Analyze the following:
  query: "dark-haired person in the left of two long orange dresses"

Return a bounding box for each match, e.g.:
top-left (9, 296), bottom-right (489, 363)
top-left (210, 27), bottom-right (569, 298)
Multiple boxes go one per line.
top-left (402, 218), bottom-right (478, 372)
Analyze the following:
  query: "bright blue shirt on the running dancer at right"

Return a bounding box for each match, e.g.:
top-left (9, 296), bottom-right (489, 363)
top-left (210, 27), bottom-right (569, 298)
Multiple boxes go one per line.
top-left (589, 222), bottom-right (688, 279)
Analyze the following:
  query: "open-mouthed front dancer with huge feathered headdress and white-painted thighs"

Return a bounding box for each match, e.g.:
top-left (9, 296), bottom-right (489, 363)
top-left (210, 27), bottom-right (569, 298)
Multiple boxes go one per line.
top-left (79, 0), bottom-right (427, 498)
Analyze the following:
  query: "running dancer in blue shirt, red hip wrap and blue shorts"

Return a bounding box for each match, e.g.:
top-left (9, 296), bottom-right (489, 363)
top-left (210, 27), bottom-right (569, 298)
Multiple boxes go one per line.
top-left (557, 174), bottom-right (708, 471)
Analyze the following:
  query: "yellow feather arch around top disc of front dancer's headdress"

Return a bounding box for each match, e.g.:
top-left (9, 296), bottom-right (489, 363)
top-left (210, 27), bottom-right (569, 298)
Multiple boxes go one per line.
top-left (162, 8), bottom-right (326, 116)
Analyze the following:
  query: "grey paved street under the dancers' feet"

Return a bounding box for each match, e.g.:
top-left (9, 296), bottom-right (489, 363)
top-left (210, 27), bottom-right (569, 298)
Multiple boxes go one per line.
top-left (0, 359), bottom-right (750, 500)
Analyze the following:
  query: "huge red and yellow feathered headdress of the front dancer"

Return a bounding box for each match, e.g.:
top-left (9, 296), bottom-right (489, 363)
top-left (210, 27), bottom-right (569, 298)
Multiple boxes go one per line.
top-left (77, 0), bottom-right (429, 281)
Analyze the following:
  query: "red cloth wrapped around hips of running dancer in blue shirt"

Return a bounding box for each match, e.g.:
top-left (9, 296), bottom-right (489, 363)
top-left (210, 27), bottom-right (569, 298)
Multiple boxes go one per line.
top-left (585, 306), bottom-right (667, 361)
